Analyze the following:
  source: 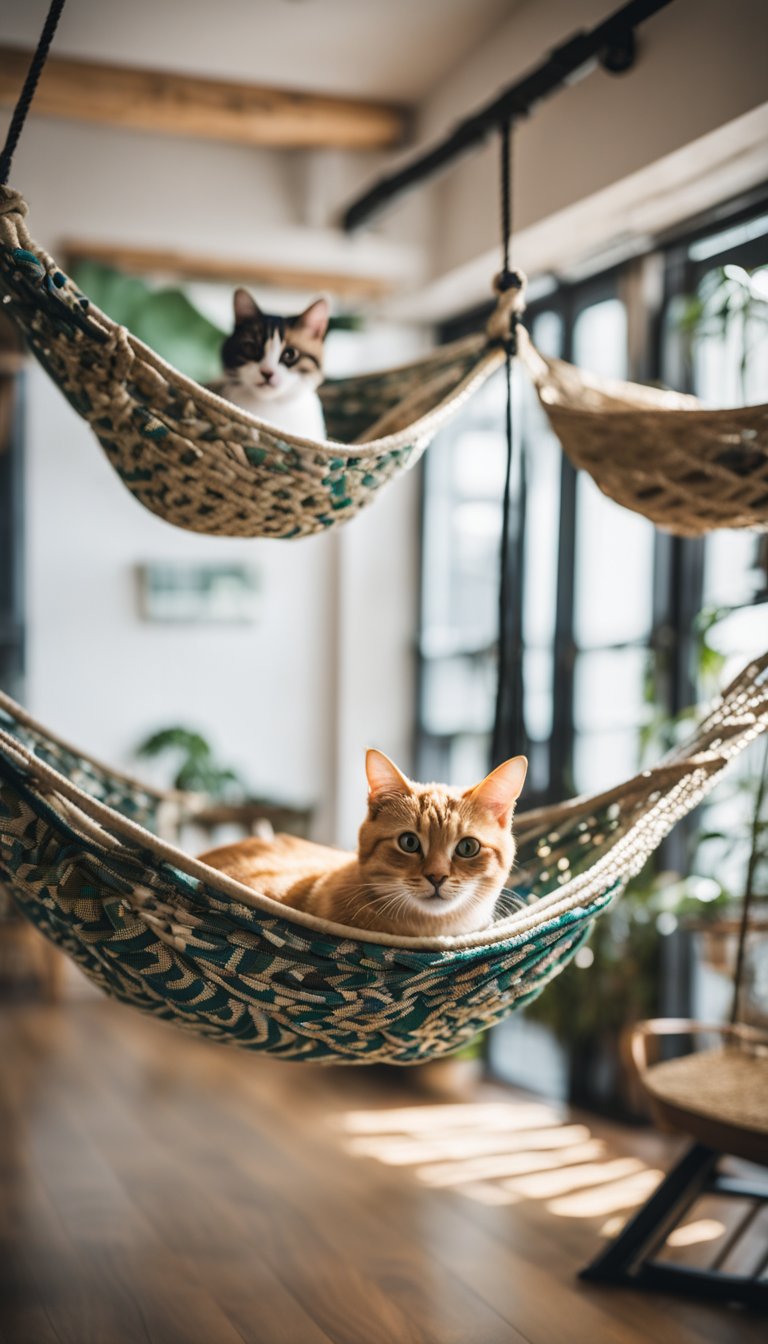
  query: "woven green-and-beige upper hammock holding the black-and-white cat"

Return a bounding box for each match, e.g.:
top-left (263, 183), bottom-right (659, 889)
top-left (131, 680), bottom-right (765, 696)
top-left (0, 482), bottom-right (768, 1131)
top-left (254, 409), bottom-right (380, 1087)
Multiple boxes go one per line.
top-left (0, 187), bottom-right (508, 538)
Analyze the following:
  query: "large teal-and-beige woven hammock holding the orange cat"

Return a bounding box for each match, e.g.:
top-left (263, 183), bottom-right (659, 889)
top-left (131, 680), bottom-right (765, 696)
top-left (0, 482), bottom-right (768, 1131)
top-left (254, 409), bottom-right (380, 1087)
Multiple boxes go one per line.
top-left (0, 653), bottom-right (768, 1064)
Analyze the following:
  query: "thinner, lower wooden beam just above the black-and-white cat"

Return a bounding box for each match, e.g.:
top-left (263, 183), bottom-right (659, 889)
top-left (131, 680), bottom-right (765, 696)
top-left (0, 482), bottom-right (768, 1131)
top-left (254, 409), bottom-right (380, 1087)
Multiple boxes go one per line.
top-left (56, 239), bottom-right (394, 301)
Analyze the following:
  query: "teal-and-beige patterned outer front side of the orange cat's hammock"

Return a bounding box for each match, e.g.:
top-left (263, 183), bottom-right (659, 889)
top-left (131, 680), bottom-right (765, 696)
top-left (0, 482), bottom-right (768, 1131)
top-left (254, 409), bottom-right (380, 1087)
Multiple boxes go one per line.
top-left (0, 761), bottom-right (599, 1063)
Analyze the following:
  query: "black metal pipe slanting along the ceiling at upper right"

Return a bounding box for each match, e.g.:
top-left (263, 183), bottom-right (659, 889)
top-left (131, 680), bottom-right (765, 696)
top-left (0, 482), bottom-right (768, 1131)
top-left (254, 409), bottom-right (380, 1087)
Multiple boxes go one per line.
top-left (342, 0), bottom-right (673, 233)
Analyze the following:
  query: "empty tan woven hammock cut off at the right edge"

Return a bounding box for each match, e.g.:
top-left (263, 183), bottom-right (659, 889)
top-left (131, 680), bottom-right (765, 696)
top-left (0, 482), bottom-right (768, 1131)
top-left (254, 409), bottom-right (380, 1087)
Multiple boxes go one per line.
top-left (518, 332), bottom-right (768, 536)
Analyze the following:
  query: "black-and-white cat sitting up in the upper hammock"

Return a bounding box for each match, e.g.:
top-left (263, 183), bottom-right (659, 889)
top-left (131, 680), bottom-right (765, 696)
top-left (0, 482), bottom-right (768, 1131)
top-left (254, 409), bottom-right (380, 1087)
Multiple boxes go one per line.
top-left (210, 289), bottom-right (328, 438)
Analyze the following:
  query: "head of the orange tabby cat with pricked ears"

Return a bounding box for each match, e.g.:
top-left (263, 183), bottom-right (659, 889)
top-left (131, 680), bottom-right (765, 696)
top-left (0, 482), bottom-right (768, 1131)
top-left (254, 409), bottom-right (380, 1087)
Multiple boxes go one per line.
top-left (356, 751), bottom-right (527, 937)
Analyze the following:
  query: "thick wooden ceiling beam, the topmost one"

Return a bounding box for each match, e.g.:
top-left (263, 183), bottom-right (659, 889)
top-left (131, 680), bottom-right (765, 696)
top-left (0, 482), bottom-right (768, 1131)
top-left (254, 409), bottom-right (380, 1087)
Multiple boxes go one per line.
top-left (0, 46), bottom-right (406, 149)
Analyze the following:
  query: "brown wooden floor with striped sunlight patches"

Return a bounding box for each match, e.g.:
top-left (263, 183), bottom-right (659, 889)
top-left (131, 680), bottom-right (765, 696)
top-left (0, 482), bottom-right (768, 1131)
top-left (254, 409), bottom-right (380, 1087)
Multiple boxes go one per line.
top-left (0, 1000), bottom-right (765, 1344)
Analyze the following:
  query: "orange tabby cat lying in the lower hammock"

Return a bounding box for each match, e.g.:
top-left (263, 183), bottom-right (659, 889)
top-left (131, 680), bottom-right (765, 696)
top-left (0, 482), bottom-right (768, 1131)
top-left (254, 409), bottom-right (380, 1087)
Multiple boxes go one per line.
top-left (200, 750), bottom-right (527, 937)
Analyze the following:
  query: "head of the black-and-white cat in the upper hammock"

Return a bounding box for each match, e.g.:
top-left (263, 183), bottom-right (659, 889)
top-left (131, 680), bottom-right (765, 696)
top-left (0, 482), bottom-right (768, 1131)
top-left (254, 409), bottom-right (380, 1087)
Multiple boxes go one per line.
top-left (222, 289), bottom-right (328, 401)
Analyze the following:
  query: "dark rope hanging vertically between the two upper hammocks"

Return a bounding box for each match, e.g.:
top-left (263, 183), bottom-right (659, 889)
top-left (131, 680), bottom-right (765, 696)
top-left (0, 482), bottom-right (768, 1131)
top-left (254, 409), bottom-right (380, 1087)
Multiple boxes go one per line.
top-left (491, 121), bottom-right (526, 765)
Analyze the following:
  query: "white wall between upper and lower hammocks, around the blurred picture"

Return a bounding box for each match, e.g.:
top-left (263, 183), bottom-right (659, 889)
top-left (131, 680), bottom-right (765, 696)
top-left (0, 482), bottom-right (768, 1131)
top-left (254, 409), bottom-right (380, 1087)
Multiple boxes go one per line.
top-left (26, 352), bottom-right (416, 843)
